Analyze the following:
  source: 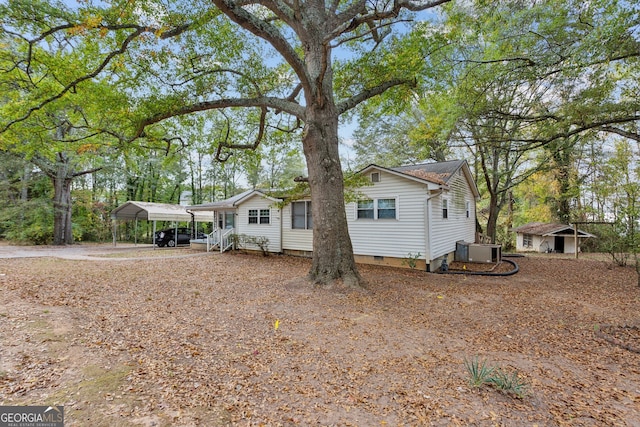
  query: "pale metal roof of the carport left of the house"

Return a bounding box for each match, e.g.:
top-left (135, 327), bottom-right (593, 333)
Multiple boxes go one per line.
top-left (111, 201), bottom-right (213, 222)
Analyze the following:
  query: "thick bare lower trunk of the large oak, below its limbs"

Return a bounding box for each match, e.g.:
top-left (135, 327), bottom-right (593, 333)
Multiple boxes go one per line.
top-left (303, 106), bottom-right (360, 287)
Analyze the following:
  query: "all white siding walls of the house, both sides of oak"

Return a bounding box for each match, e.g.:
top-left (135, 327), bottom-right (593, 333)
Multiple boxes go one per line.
top-left (231, 165), bottom-right (476, 263)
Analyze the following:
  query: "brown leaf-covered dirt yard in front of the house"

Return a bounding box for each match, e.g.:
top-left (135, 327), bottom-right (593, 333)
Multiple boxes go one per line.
top-left (0, 246), bottom-right (640, 426)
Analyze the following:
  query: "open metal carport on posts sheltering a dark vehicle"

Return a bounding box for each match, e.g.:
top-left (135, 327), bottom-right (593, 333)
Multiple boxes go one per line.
top-left (111, 201), bottom-right (214, 247)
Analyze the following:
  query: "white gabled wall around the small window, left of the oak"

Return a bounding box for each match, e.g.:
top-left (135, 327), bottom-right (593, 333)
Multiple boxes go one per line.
top-left (235, 196), bottom-right (282, 252)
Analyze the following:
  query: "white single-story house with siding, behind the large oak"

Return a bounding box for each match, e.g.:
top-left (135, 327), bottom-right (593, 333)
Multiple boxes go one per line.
top-left (187, 160), bottom-right (480, 271)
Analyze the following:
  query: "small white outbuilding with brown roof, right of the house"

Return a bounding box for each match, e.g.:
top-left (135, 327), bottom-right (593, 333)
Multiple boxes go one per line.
top-left (511, 222), bottom-right (596, 254)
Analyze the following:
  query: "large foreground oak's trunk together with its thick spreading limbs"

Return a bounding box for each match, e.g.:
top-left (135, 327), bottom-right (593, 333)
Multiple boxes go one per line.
top-left (134, 0), bottom-right (449, 286)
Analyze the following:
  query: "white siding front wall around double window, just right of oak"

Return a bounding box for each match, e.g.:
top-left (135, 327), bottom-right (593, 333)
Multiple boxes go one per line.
top-left (346, 171), bottom-right (427, 259)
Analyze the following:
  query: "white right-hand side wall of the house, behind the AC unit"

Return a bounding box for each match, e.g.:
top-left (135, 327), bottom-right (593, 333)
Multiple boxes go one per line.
top-left (430, 169), bottom-right (476, 259)
